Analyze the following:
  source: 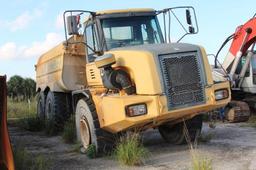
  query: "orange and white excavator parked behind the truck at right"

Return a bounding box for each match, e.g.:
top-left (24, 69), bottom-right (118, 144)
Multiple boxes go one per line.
top-left (213, 14), bottom-right (256, 122)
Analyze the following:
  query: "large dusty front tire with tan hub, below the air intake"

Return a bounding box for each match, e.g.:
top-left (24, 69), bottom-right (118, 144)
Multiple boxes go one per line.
top-left (76, 98), bottom-right (114, 154)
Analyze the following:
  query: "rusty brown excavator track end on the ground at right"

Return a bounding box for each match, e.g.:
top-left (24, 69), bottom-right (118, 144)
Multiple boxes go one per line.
top-left (225, 100), bottom-right (250, 123)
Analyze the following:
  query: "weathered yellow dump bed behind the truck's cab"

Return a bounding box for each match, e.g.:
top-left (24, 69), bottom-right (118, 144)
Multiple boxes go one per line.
top-left (36, 36), bottom-right (86, 92)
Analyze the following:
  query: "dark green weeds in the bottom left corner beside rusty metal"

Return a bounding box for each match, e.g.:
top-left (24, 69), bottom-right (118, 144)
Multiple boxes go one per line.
top-left (13, 143), bottom-right (52, 170)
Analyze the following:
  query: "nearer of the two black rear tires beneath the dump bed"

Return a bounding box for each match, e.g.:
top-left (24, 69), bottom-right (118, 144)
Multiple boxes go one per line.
top-left (45, 91), bottom-right (70, 131)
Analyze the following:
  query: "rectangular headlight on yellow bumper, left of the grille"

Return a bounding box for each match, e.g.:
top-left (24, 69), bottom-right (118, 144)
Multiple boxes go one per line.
top-left (125, 103), bottom-right (147, 117)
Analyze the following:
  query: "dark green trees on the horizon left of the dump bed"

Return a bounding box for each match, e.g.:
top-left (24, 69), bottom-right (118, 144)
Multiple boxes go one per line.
top-left (7, 75), bottom-right (36, 100)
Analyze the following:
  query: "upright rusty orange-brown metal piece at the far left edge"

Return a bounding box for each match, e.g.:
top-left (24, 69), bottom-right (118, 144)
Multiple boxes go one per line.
top-left (0, 76), bottom-right (14, 170)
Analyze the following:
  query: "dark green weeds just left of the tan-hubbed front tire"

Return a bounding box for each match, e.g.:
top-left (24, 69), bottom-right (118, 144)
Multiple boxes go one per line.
top-left (62, 115), bottom-right (76, 144)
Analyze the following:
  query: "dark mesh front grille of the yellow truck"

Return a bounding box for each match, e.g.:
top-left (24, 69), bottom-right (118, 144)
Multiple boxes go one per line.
top-left (159, 52), bottom-right (205, 110)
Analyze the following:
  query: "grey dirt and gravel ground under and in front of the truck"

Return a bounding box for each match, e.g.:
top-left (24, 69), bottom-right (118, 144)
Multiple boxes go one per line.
top-left (9, 123), bottom-right (256, 170)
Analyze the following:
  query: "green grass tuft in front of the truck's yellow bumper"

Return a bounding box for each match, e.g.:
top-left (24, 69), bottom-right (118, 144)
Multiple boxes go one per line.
top-left (114, 133), bottom-right (149, 166)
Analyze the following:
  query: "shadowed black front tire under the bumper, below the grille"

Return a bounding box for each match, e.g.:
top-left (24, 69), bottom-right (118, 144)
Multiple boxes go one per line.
top-left (158, 115), bottom-right (203, 145)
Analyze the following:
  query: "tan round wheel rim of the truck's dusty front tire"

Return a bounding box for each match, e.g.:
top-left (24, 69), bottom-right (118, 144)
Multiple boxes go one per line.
top-left (80, 117), bottom-right (90, 149)
